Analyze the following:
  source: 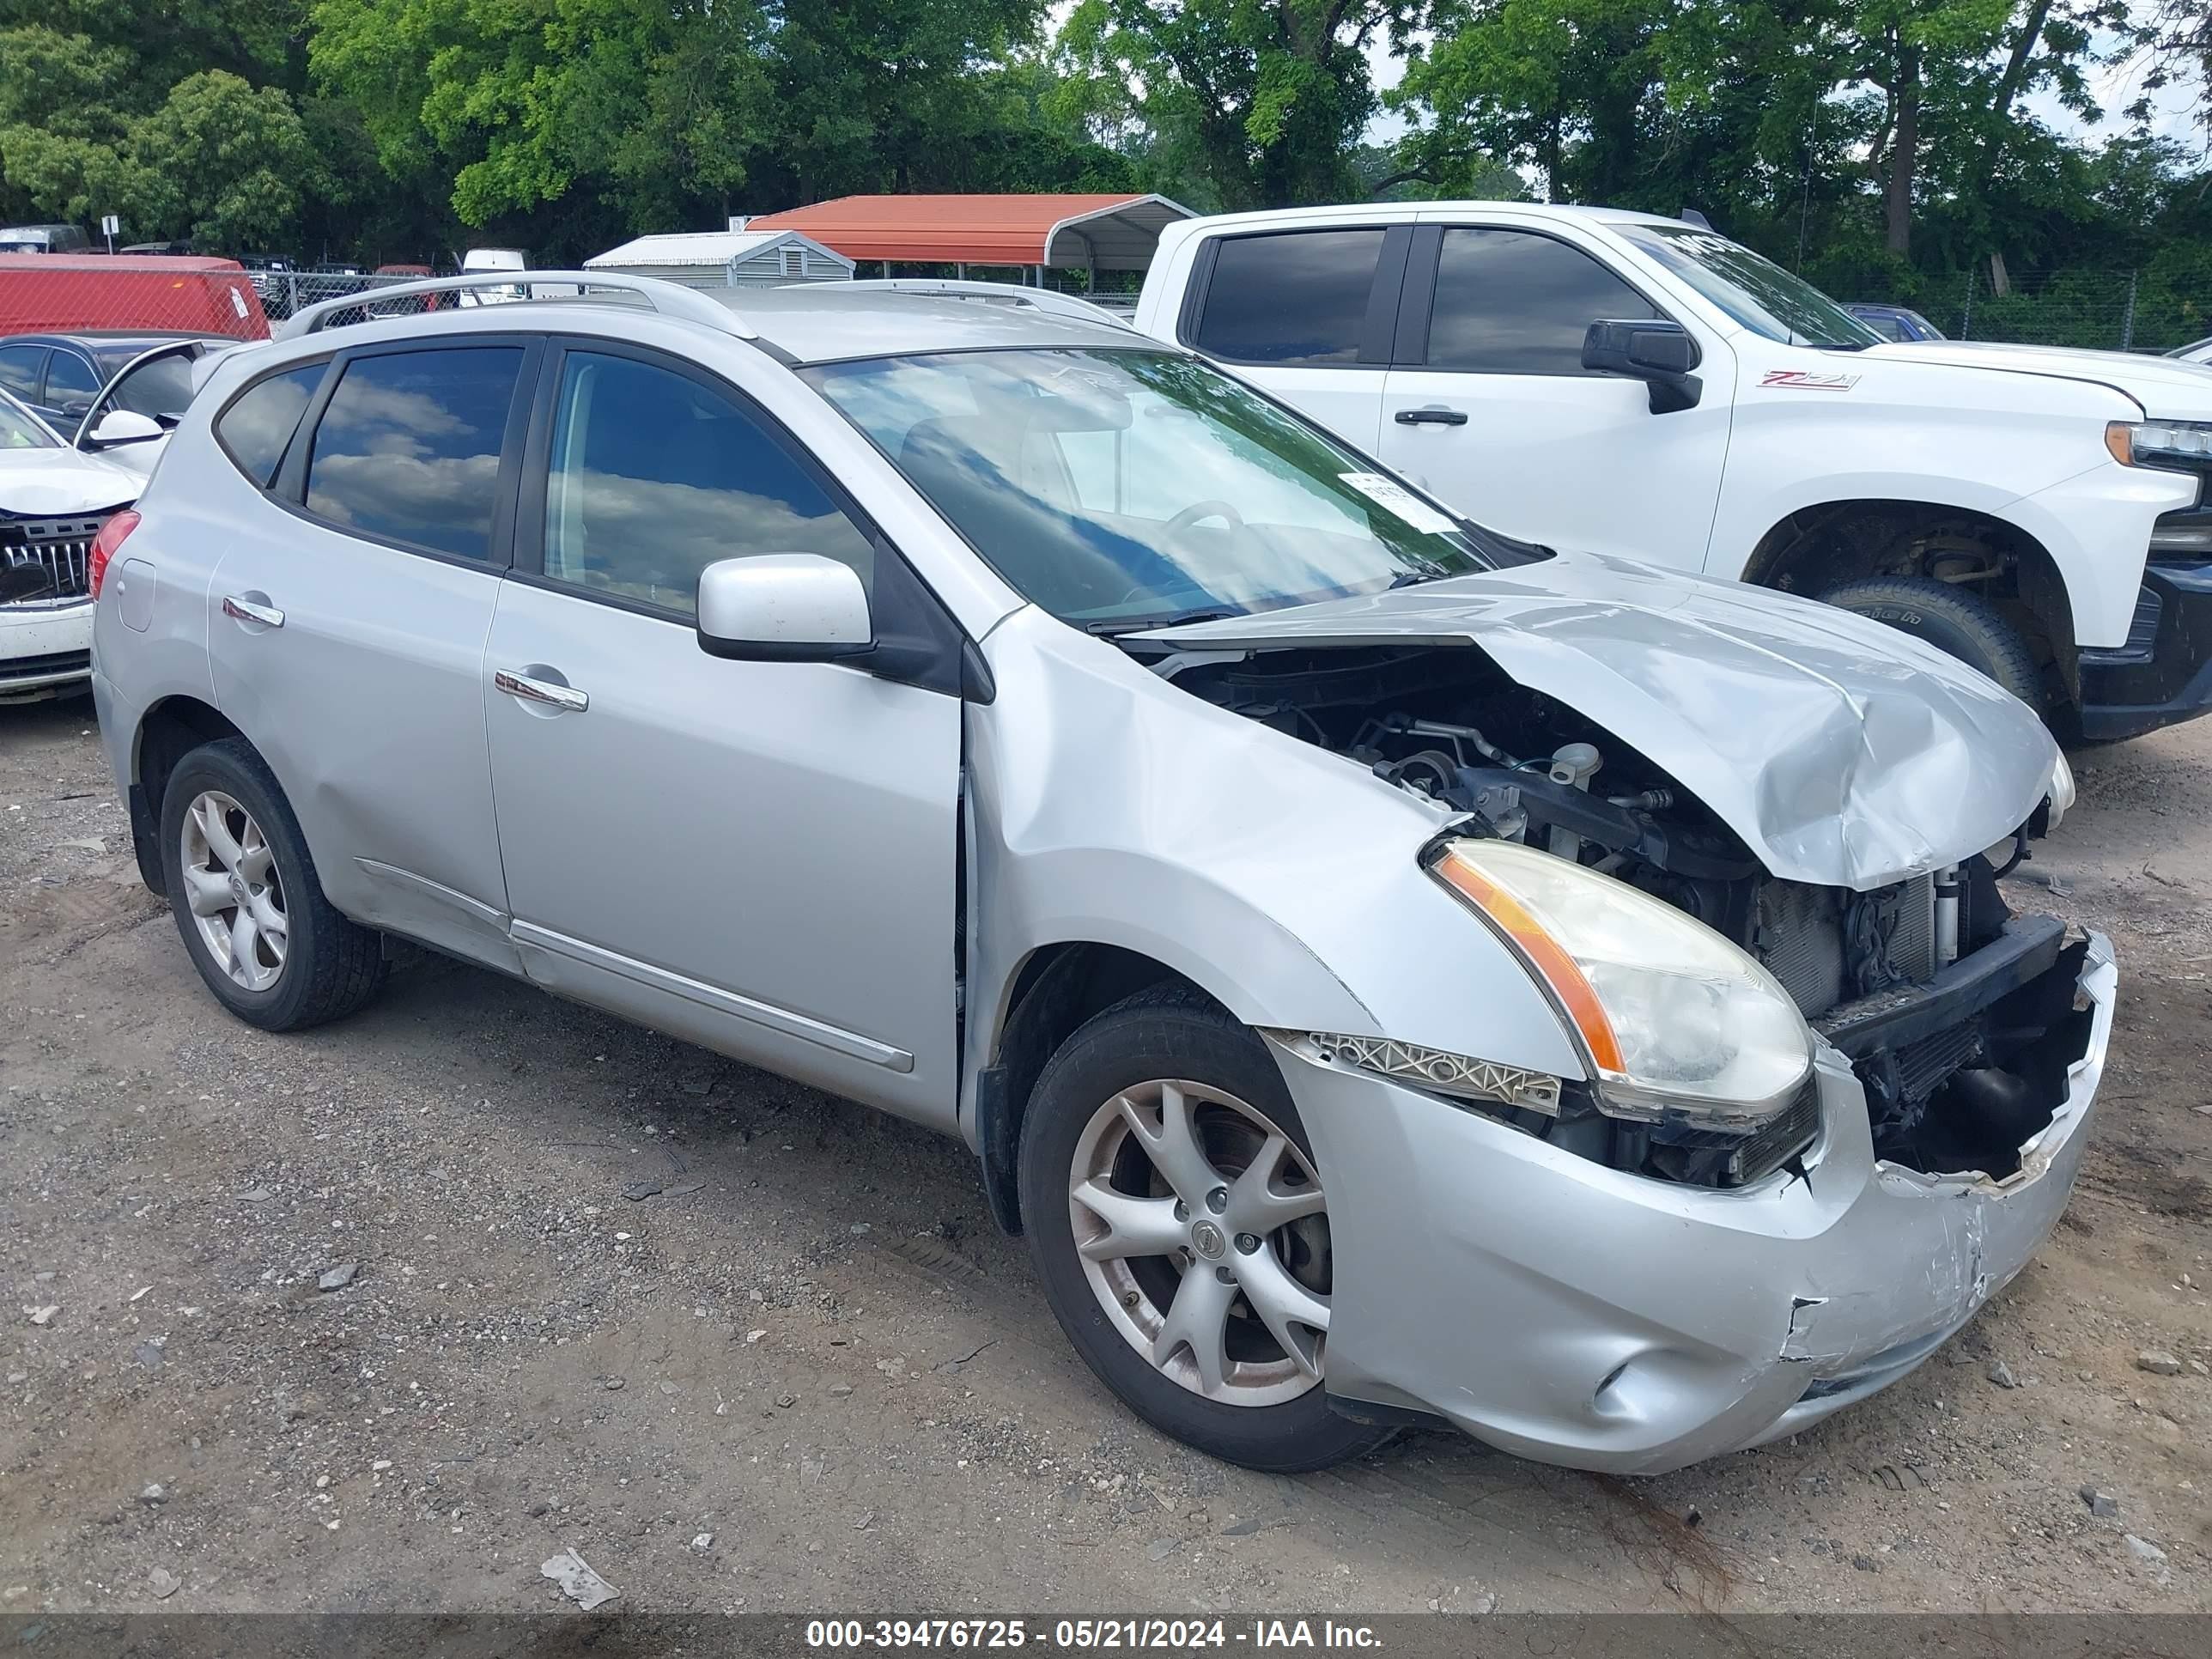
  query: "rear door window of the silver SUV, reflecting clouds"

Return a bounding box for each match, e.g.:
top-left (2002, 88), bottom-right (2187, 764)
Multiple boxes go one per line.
top-left (307, 345), bottom-right (522, 560)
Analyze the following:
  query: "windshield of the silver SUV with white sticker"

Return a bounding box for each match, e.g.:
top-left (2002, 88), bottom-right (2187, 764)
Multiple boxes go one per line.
top-left (805, 349), bottom-right (1535, 633)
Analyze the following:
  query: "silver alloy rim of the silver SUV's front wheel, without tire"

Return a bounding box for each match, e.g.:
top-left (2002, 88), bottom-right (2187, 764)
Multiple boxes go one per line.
top-left (1068, 1079), bottom-right (1329, 1407)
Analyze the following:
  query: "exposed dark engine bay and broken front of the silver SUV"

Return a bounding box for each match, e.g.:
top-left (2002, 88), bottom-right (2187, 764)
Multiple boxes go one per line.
top-left (1155, 644), bottom-right (2090, 1186)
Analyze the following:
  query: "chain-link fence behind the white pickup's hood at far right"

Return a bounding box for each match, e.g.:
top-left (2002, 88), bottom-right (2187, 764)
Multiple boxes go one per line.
top-left (1851, 265), bottom-right (2212, 352)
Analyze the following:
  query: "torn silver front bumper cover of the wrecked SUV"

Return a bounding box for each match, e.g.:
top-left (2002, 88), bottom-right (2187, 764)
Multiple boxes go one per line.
top-left (1274, 936), bottom-right (2119, 1474)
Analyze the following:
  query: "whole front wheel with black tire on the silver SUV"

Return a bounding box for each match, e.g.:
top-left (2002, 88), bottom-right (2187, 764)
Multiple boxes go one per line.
top-left (1020, 991), bottom-right (1389, 1474)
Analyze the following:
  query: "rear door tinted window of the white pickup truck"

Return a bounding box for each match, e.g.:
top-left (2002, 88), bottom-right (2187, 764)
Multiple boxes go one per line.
top-left (1197, 226), bottom-right (1387, 362)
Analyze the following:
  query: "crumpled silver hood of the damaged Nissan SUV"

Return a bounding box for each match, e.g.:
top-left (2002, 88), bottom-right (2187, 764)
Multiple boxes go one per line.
top-left (1133, 553), bottom-right (2057, 890)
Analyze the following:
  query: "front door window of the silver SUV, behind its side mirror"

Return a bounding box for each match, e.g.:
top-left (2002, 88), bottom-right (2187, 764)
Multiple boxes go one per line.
top-left (544, 352), bottom-right (874, 615)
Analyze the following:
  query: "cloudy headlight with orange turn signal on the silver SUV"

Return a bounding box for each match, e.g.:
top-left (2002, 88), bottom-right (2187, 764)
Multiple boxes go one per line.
top-left (1431, 841), bottom-right (1812, 1133)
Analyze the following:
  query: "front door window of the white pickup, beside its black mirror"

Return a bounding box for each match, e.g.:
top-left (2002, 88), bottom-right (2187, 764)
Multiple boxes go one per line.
top-left (1429, 230), bottom-right (1656, 374)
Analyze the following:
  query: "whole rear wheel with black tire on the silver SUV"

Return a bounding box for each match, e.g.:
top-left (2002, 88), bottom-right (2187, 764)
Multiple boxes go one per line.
top-left (161, 737), bottom-right (385, 1030)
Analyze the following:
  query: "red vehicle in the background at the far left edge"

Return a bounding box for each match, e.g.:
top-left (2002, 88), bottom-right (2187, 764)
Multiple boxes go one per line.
top-left (0, 254), bottom-right (270, 341)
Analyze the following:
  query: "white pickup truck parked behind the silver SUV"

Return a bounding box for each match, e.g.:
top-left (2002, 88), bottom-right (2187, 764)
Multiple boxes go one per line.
top-left (1137, 201), bottom-right (2212, 738)
